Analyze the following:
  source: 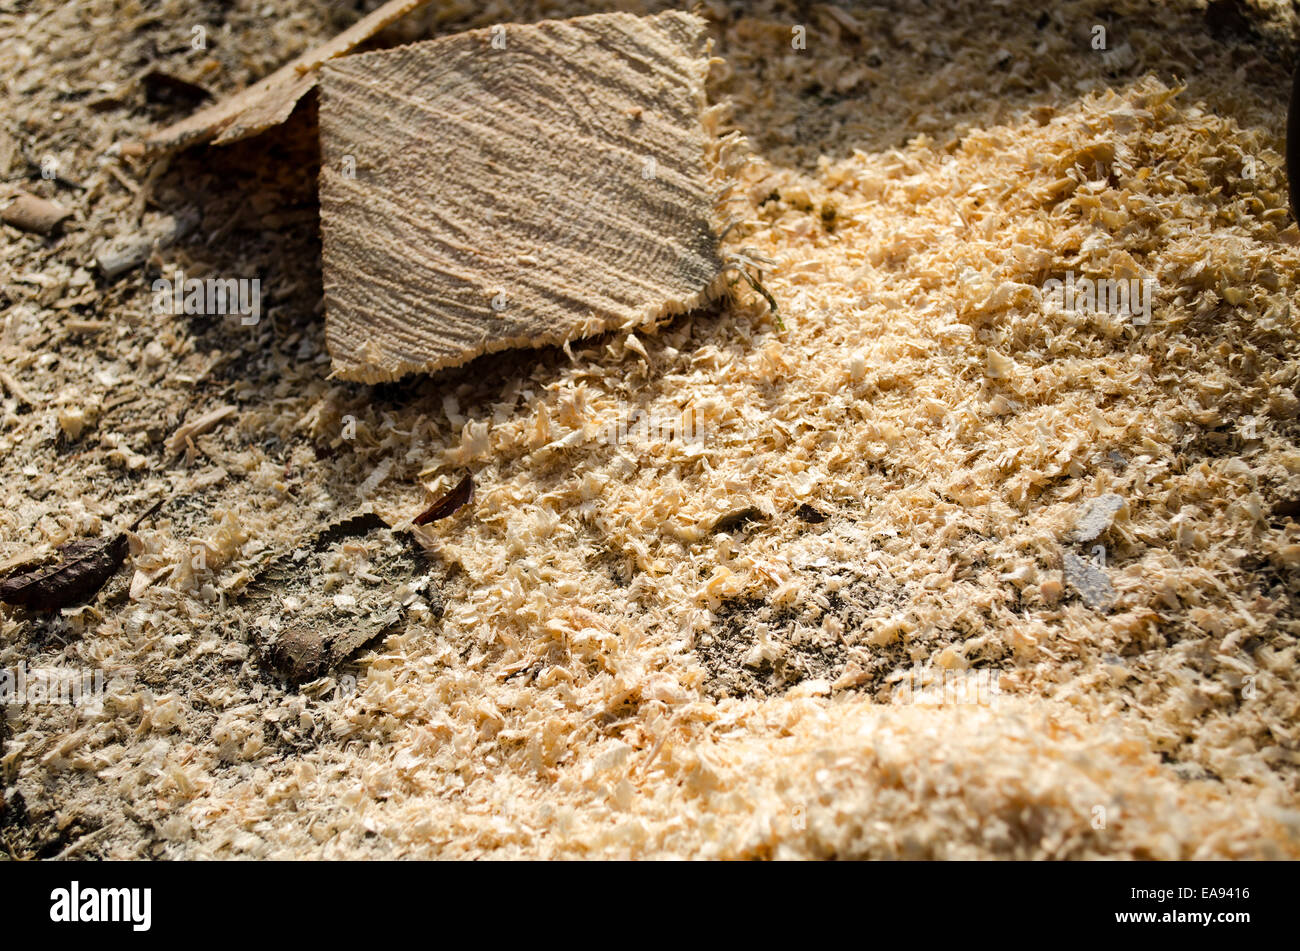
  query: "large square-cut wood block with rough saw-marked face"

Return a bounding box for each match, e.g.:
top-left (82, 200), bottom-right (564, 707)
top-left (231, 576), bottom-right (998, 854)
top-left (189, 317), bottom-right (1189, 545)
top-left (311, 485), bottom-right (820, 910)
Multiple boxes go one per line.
top-left (310, 13), bottom-right (722, 383)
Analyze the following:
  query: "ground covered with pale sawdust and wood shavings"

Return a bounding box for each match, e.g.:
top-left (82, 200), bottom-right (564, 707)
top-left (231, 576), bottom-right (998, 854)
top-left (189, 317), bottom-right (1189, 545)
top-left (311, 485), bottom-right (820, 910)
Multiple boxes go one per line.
top-left (0, 0), bottom-right (1300, 859)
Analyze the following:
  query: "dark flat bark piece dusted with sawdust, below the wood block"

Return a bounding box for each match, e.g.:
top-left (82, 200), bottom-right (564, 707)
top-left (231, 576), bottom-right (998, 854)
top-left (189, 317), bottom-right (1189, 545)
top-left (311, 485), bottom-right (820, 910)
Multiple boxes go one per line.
top-left (236, 511), bottom-right (442, 682)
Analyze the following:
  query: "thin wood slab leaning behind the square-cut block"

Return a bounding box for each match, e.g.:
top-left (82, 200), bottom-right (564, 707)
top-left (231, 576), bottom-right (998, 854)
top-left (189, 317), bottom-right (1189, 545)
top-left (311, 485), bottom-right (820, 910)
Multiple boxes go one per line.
top-left (144, 0), bottom-right (429, 152)
